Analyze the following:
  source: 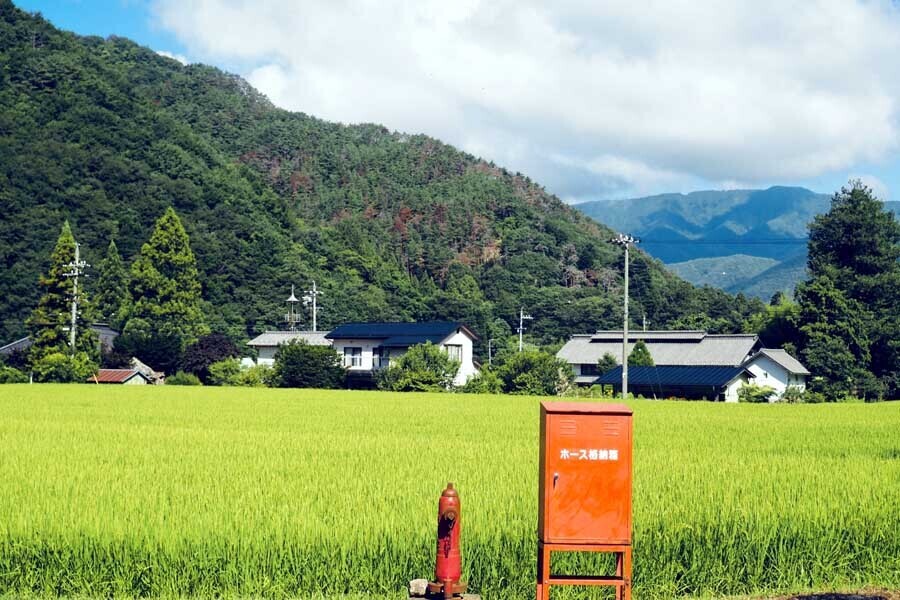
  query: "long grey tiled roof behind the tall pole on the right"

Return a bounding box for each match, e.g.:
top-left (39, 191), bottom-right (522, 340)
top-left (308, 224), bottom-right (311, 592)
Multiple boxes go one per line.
top-left (556, 331), bottom-right (759, 367)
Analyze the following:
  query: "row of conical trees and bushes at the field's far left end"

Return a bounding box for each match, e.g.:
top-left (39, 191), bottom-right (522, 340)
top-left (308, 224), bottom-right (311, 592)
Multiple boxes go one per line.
top-left (5, 208), bottom-right (207, 382)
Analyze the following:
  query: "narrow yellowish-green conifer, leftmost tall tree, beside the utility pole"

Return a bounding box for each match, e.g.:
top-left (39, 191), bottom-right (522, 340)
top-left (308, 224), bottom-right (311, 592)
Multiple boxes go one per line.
top-left (28, 221), bottom-right (97, 381)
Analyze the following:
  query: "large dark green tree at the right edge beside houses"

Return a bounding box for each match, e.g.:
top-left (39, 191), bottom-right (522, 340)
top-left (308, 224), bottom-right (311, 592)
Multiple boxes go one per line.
top-left (797, 181), bottom-right (900, 400)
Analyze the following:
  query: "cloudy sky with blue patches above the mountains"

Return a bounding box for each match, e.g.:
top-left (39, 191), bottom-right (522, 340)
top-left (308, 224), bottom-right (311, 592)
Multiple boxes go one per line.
top-left (14, 0), bottom-right (900, 202)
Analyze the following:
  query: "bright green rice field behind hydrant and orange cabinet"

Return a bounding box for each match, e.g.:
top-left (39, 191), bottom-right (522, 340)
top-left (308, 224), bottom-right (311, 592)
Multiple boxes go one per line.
top-left (0, 385), bottom-right (900, 600)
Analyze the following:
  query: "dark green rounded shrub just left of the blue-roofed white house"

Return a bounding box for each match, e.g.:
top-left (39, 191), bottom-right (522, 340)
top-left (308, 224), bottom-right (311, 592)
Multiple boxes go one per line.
top-left (272, 340), bottom-right (345, 388)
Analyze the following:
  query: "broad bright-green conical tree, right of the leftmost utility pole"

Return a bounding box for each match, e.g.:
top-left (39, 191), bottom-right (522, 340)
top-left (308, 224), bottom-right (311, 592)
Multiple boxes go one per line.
top-left (122, 207), bottom-right (209, 373)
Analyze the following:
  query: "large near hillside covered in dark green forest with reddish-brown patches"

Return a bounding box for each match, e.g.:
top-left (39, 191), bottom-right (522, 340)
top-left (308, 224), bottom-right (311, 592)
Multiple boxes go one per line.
top-left (0, 0), bottom-right (759, 352)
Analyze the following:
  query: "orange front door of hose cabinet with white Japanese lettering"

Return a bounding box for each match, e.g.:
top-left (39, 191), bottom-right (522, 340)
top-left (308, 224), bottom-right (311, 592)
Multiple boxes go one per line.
top-left (544, 414), bottom-right (631, 544)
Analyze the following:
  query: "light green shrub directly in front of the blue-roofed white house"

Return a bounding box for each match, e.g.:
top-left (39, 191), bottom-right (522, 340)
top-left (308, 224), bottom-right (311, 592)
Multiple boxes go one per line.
top-left (378, 342), bottom-right (459, 392)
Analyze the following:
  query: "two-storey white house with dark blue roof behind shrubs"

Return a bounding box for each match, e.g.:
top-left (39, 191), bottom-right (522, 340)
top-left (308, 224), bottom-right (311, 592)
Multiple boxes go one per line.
top-left (325, 321), bottom-right (478, 385)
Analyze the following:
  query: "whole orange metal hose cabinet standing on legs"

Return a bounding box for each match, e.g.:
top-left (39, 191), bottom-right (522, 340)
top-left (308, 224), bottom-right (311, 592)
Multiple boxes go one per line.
top-left (538, 402), bottom-right (632, 600)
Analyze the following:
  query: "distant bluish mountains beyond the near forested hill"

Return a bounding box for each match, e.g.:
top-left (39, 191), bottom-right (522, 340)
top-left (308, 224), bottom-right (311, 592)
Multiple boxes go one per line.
top-left (575, 186), bottom-right (900, 299)
